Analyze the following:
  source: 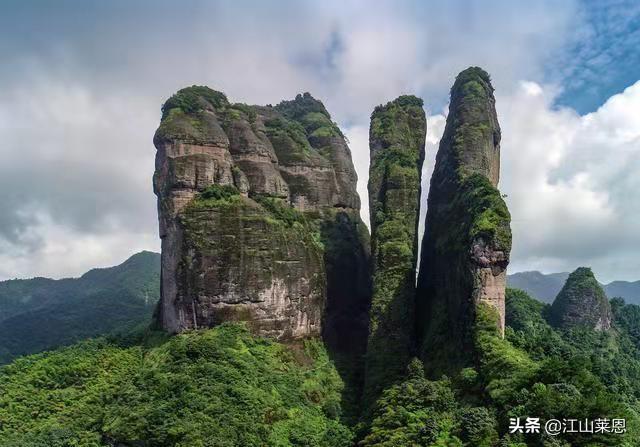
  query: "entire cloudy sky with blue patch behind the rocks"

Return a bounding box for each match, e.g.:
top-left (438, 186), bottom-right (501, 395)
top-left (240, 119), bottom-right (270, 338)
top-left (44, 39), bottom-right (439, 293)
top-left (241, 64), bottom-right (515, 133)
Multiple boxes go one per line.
top-left (0, 0), bottom-right (640, 281)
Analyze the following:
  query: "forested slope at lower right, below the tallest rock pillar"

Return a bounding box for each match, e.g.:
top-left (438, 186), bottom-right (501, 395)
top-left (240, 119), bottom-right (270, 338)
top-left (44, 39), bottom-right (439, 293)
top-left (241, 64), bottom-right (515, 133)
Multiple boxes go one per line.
top-left (361, 289), bottom-right (640, 447)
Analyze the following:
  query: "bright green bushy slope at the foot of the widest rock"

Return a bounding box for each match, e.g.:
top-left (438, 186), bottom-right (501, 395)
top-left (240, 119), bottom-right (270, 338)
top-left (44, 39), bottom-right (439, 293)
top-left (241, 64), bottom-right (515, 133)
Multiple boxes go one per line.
top-left (0, 324), bottom-right (352, 447)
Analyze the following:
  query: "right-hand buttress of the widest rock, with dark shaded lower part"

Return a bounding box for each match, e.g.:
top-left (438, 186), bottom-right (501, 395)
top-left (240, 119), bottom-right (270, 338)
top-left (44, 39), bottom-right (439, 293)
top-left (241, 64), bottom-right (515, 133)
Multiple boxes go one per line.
top-left (273, 93), bottom-right (371, 360)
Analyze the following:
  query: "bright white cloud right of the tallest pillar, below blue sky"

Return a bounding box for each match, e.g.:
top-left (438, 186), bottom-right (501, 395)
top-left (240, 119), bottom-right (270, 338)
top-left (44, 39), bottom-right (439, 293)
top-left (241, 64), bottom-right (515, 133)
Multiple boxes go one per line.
top-left (497, 82), bottom-right (640, 280)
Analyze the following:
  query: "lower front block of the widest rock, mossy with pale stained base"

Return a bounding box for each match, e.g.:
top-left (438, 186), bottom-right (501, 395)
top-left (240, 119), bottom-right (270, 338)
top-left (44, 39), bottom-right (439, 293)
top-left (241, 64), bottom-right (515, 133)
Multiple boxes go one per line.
top-left (175, 196), bottom-right (326, 340)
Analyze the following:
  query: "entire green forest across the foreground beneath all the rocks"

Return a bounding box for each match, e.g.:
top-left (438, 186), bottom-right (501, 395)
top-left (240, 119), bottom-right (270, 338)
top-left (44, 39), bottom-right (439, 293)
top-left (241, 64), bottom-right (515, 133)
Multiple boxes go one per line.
top-left (0, 289), bottom-right (640, 447)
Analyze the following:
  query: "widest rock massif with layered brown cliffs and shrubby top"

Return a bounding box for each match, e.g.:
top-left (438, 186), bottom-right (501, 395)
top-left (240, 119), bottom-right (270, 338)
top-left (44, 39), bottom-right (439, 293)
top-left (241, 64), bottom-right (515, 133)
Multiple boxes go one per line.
top-left (154, 86), bottom-right (370, 345)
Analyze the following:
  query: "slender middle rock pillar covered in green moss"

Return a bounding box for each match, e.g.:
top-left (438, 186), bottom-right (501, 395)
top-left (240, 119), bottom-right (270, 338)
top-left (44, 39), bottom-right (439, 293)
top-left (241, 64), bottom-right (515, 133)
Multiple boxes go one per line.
top-left (365, 96), bottom-right (427, 401)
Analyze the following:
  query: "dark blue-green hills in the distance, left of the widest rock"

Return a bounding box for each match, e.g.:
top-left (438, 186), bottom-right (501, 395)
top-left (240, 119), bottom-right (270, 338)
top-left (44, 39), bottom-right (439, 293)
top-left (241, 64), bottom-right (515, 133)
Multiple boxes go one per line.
top-left (0, 251), bottom-right (160, 364)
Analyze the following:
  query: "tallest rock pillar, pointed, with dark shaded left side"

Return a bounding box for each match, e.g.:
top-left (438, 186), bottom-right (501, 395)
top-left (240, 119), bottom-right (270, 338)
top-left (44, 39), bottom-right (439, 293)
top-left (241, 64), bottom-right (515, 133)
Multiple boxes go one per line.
top-left (416, 67), bottom-right (511, 369)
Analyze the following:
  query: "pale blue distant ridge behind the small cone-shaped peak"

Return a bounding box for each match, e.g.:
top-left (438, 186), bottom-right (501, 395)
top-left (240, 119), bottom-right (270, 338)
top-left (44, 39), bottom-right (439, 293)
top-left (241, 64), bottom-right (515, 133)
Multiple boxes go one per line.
top-left (507, 271), bottom-right (640, 305)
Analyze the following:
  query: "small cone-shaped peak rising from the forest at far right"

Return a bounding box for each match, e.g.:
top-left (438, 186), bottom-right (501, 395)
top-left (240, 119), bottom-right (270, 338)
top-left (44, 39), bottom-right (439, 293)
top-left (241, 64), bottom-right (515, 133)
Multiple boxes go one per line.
top-left (551, 267), bottom-right (612, 331)
